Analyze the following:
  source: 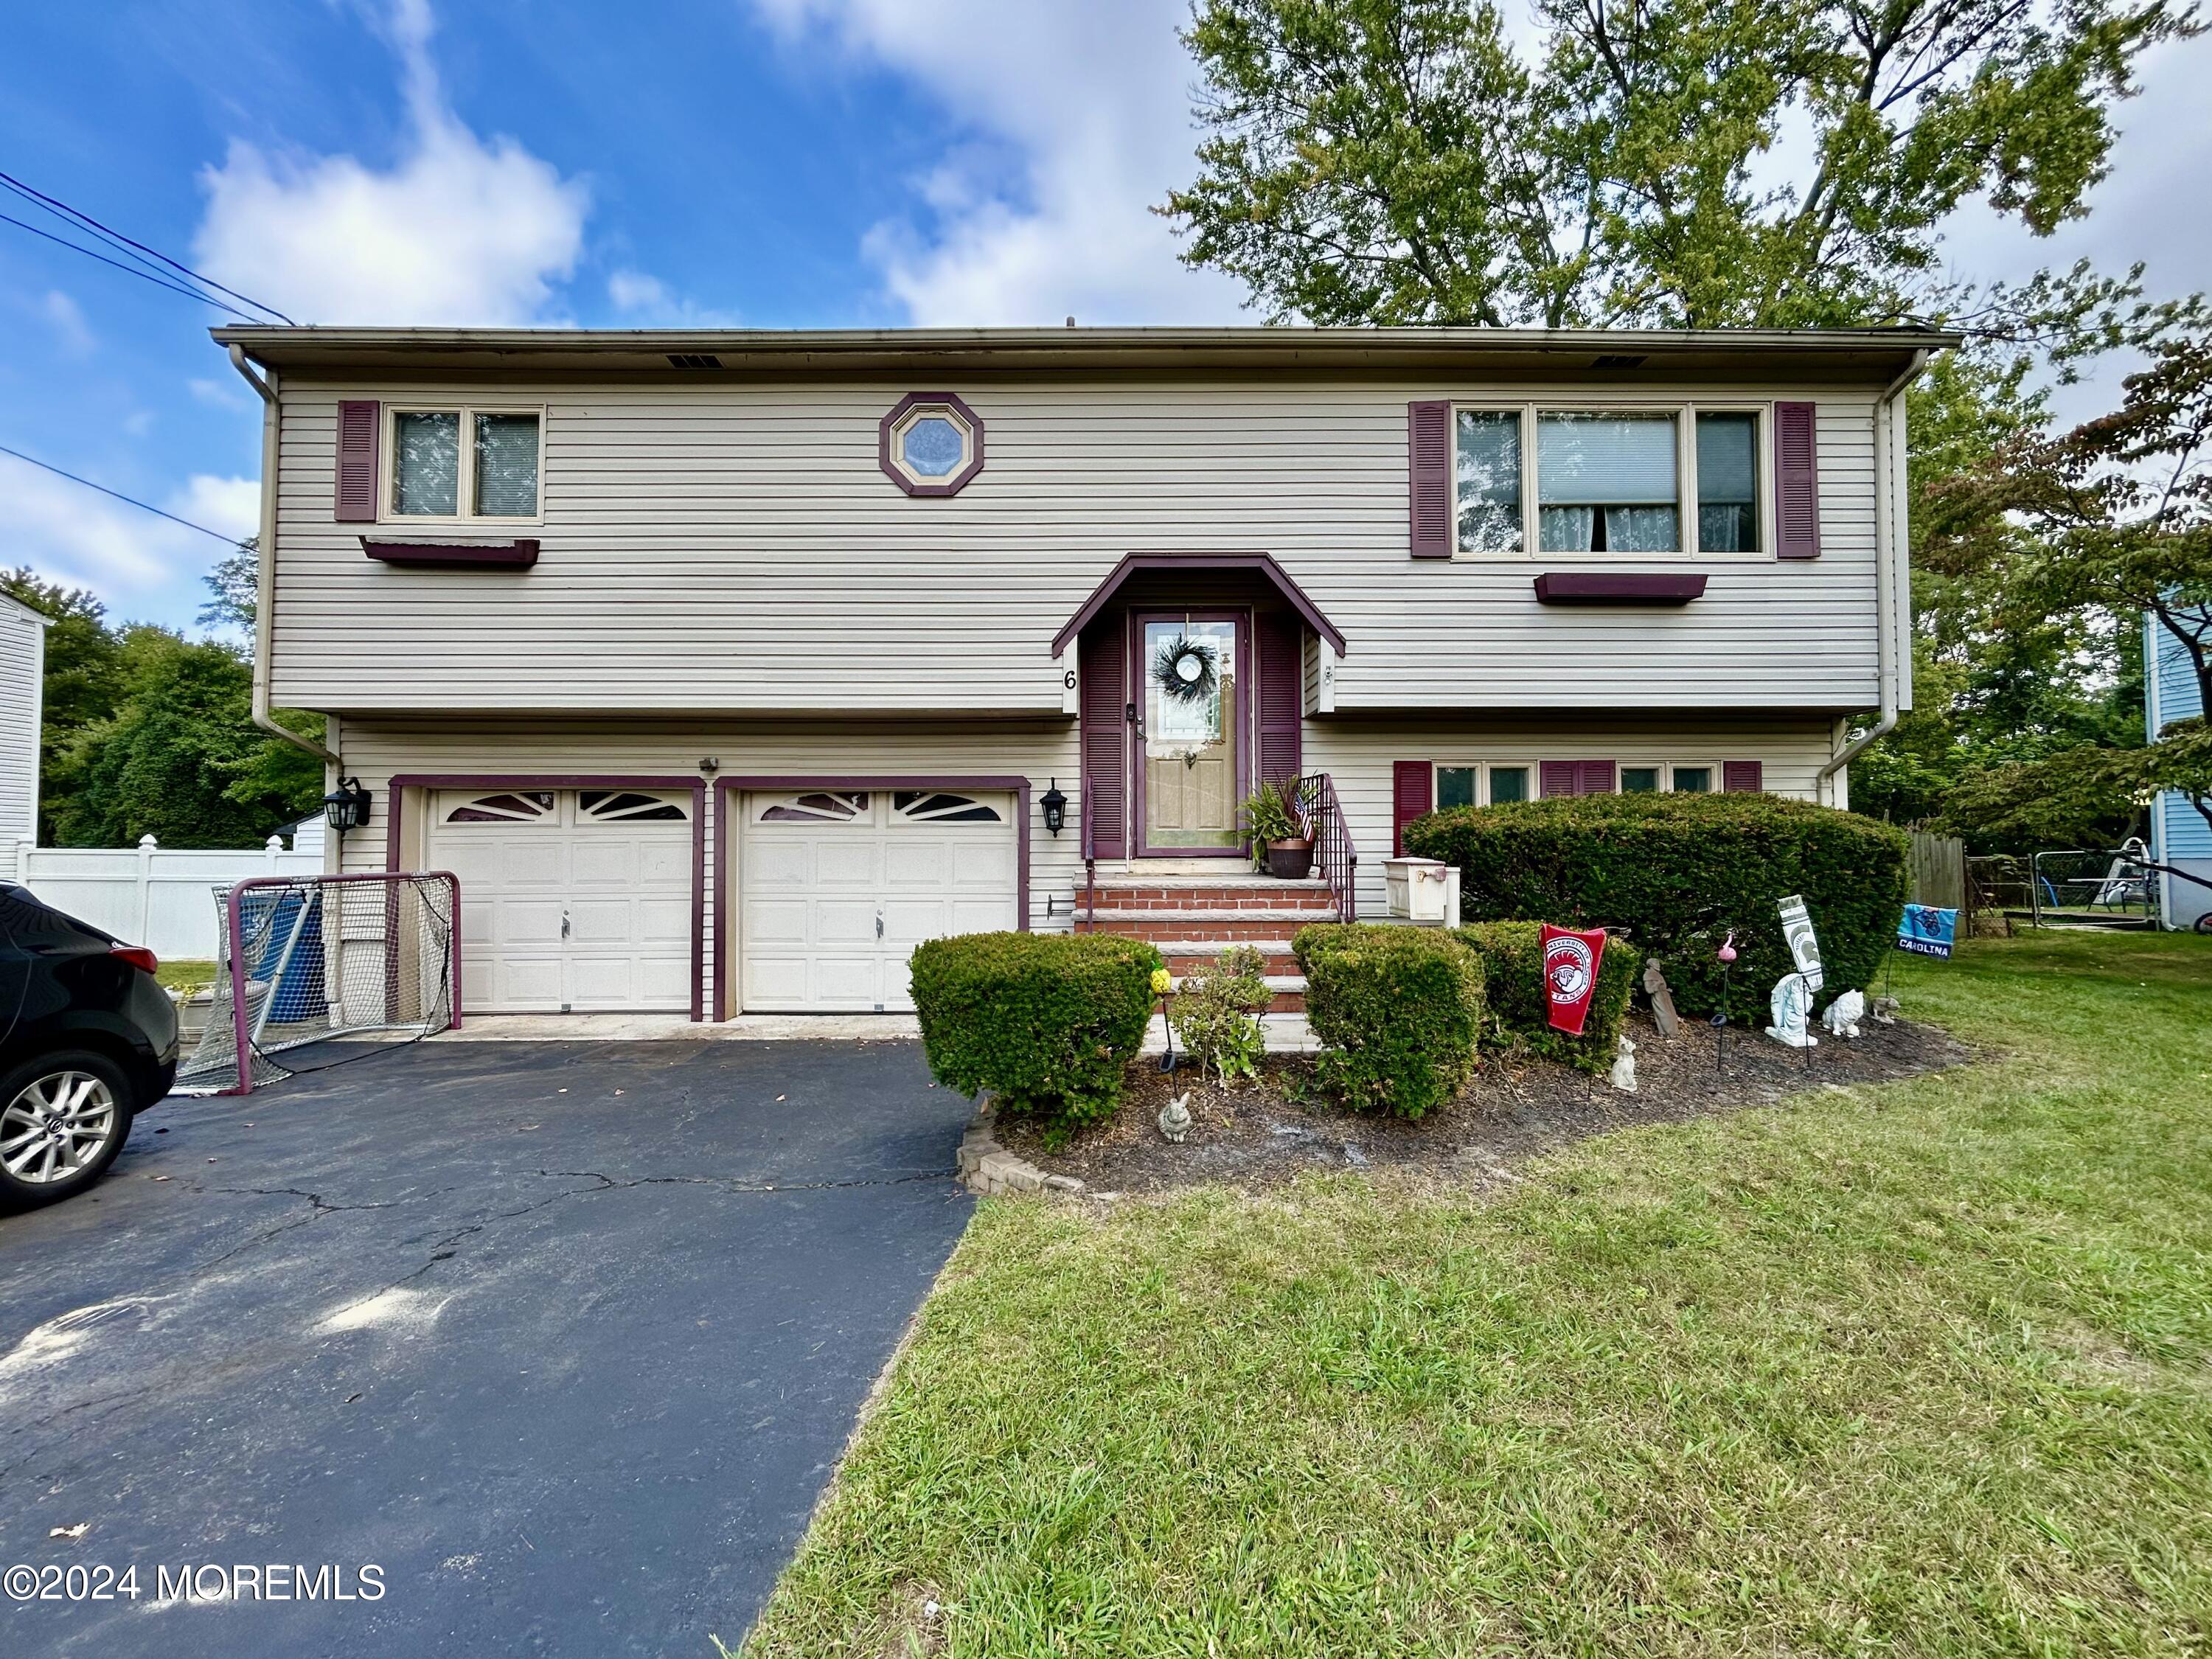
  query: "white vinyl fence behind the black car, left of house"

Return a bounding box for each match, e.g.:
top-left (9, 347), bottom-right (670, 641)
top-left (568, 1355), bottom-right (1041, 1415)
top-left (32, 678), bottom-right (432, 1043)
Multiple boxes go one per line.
top-left (15, 836), bottom-right (323, 960)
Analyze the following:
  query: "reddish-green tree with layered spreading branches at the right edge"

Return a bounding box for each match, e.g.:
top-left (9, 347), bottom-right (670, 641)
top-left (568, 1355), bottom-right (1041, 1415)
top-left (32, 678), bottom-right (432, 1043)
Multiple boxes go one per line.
top-left (1924, 327), bottom-right (2212, 845)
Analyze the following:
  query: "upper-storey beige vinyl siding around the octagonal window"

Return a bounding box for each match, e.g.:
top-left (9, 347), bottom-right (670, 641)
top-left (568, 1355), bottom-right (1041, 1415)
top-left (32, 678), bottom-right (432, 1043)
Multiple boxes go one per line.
top-left (272, 376), bottom-right (1876, 712)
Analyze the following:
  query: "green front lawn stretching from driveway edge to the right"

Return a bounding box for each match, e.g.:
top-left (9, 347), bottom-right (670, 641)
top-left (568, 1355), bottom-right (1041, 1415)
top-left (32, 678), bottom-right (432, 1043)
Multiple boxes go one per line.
top-left (745, 933), bottom-right (2212, 1659)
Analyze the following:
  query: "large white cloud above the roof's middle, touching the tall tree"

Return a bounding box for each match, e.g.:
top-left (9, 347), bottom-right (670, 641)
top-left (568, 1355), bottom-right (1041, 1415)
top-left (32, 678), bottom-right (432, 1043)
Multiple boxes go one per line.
top-left (752, 0), bottom-right (1243, 325)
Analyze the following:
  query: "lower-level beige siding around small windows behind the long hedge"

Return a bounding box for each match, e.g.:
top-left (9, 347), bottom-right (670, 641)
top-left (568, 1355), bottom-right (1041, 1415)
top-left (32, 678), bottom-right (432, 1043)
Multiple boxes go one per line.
top-left (1305, 719), bottom-right (1843, 920)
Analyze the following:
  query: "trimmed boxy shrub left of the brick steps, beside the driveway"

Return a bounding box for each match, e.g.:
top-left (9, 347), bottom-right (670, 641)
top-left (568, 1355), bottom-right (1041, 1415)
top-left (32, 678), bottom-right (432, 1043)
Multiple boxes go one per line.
top-left (911, 933), bottom-right (1159, 1130)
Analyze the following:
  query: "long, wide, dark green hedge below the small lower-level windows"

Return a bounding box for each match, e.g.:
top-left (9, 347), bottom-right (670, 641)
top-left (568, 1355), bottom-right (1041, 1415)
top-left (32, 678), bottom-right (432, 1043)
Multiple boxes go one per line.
top-left (1405, 794), bottom-right (1907, 1013)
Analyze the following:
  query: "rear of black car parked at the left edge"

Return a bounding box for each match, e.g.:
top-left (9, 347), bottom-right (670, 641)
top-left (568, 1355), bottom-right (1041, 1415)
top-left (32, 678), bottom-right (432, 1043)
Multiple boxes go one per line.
top-left (0, 883), bottom-right (177, 1208)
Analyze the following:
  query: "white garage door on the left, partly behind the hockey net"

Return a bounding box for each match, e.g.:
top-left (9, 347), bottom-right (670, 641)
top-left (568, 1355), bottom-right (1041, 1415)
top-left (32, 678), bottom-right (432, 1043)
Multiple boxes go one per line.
top-left (429, 790), bottom-right (692, 1013)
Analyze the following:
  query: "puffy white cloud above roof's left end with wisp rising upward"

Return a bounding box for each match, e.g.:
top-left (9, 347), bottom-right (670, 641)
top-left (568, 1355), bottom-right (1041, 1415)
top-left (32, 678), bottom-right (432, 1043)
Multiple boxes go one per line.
top-left (192, 0), bottom-right (591, 325)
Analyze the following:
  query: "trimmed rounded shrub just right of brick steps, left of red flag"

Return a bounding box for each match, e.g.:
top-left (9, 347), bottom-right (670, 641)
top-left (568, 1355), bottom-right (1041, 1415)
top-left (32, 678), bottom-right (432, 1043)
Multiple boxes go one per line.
top-left (1292, 922), bottom-right (1482, 1117)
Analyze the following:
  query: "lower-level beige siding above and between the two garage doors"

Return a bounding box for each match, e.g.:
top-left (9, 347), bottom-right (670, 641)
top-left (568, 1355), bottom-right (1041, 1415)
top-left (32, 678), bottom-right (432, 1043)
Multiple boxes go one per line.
top-left (343, 719), bottom-right (1082, 1015)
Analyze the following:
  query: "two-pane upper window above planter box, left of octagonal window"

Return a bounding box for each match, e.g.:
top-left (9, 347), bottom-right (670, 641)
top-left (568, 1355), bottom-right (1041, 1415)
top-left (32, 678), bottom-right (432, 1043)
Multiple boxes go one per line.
top-left (383, 405), bottom-right (546, 524)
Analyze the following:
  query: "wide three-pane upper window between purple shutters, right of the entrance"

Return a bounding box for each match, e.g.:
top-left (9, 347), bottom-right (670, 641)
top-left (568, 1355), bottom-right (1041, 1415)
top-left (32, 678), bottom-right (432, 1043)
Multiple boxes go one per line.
top-left (1453, 400), bottom-right (1774, 557)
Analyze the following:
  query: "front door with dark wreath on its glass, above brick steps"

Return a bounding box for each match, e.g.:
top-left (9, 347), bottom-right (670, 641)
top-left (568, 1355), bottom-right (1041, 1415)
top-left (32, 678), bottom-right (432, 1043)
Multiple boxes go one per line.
top-left (1133, 613), bottom-right (1245, 858)
